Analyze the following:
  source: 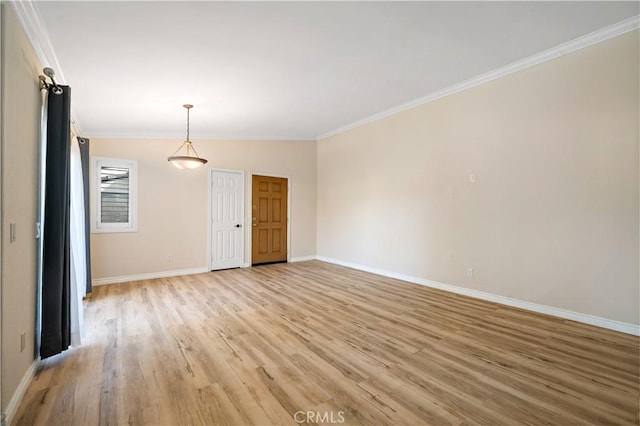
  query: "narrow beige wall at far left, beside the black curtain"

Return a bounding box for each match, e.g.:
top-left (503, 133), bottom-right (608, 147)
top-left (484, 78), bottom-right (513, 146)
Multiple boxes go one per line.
top-left (0, 4), bottom-right (42, 411)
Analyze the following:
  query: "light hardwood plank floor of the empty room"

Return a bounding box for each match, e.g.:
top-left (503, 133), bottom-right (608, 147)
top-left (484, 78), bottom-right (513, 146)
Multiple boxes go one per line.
top-left (16, 261), bottom-right (640, 425)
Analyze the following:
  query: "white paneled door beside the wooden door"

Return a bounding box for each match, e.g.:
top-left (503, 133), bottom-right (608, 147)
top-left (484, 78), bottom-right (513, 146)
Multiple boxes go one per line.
top-left (211, 170), bottom-right (244, 270)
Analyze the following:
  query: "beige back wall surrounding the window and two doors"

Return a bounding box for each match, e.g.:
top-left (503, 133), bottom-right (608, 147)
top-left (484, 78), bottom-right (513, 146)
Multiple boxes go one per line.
top-left (91, 135), bottom-right (316, 279)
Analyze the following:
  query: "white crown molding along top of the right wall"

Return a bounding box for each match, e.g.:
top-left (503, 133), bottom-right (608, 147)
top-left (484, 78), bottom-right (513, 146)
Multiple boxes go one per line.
top-left (317, 15), bottom-right (640, 141)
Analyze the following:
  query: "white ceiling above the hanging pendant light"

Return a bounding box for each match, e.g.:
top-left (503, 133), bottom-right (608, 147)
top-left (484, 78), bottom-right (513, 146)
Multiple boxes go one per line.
top-left (35, 1), bottom-right (639, 140)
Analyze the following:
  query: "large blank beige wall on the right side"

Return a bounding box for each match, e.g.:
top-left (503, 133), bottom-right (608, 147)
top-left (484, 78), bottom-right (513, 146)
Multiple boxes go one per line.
top-left (318, 31), bottom-right (639, 324)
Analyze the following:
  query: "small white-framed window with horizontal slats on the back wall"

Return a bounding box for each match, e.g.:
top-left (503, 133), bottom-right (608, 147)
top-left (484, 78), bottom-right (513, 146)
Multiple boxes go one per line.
top-left (91, 157), bottom-right (138, 232)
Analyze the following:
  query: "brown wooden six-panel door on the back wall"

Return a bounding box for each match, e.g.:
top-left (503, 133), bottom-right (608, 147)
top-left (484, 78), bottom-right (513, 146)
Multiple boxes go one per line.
top-left (251, 175), bottom-right (288, 265)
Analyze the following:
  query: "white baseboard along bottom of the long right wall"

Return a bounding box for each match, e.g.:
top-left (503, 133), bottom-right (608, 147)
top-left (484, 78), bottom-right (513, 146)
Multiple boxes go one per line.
top-left (317, 256), bottom-right (640, 336)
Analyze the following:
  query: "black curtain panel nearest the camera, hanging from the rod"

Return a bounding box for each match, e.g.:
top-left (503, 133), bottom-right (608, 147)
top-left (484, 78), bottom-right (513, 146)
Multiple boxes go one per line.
top-left (40, 86), bottom-right (71, 359)
